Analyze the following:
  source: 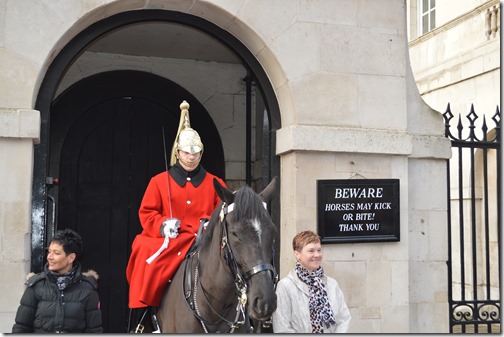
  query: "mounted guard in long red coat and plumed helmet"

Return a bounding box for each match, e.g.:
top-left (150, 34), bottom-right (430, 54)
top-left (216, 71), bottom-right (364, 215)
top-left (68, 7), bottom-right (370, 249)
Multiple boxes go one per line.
top-left (126, 101), bottom-right (226, 332)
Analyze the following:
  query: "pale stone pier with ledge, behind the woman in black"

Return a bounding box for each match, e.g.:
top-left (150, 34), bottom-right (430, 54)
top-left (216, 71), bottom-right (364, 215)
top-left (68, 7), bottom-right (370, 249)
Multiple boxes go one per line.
top-left (0, 109), bottom-right (40, 332)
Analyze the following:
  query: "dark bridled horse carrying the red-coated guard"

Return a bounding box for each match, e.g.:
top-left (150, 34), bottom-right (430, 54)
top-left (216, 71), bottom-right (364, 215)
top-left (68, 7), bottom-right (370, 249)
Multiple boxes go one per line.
top-left (157, 178), bottom-right (278, 333)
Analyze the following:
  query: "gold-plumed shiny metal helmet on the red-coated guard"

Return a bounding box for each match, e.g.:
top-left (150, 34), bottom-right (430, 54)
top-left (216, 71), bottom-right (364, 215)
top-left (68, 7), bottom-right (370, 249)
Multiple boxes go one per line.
top-left (170, 101), bottom-right (203, 166)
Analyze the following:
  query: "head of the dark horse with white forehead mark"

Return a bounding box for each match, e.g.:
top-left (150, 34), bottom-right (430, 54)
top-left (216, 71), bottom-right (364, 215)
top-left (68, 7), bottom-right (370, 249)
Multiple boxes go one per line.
top-left (214, 177), bottom-right (277, 321)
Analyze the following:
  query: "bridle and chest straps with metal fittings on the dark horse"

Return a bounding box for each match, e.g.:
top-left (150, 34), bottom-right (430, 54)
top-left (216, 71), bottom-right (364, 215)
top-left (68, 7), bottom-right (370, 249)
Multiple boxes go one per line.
top-left (183, 198), bottom-right (278, 333)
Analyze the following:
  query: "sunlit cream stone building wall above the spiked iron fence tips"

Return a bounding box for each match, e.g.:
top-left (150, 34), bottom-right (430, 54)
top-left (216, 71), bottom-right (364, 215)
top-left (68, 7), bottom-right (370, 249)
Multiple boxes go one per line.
top-left (410, 1), bottom-right (501, 116)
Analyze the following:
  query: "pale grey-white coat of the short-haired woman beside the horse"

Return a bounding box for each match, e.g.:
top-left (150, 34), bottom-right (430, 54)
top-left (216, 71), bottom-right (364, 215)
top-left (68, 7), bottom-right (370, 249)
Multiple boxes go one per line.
top-left (272, 269), bottom-right (351, 333)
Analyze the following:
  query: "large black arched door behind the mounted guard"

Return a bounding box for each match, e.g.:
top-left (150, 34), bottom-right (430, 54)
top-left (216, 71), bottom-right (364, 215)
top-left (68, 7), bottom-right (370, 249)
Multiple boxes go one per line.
top-left (46, 71), bottom-right (225, 333)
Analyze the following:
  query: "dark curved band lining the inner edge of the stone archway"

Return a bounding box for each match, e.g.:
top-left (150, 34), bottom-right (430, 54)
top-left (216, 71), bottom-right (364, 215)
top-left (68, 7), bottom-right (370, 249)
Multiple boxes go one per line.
top-left (31, 6), bottom-right (279, 332)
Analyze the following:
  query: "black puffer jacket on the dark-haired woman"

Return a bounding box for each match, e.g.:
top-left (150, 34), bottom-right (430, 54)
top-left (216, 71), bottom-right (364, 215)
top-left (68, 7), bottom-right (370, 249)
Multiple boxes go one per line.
top-left (12, 264), bottom-right (103, 333)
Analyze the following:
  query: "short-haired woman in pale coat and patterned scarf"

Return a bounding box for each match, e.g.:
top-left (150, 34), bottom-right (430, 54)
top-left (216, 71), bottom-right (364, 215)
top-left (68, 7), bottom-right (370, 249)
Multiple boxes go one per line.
top-left (272, 231), bottom-right (351, 333)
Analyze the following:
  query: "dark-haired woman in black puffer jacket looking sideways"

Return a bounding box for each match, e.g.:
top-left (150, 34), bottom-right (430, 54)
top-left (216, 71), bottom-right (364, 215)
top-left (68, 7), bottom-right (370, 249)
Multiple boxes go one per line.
top-left (12, 229), bottom-right (103, 333)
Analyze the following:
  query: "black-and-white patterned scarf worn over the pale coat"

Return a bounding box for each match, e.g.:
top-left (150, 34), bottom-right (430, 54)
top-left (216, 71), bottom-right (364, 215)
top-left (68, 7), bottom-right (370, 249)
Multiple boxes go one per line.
top-left (295, 261), bottom-right (336, 333)
